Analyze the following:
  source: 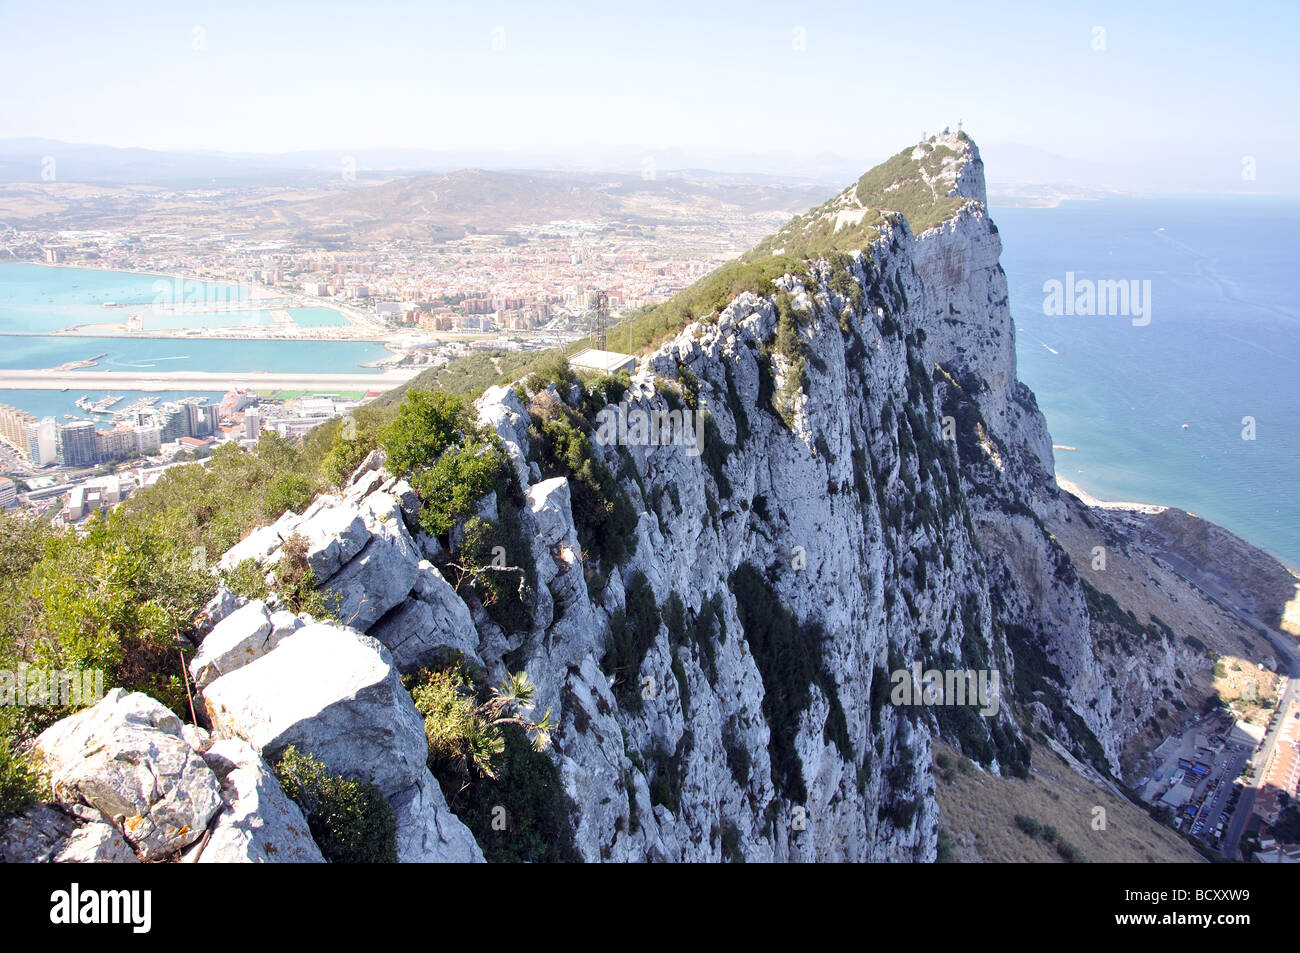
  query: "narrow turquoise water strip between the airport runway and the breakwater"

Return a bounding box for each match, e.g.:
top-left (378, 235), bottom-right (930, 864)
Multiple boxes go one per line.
top-left (0, 334), bottom-right (387, 374)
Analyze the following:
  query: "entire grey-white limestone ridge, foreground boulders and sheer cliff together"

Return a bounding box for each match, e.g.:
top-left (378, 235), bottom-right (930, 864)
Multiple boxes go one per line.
top-left (20, 134), bottom-right (1178, 861)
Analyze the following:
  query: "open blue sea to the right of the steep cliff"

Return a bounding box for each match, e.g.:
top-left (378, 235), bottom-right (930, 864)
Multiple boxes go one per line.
top-left (992, 198), bottom-right (1300, 567)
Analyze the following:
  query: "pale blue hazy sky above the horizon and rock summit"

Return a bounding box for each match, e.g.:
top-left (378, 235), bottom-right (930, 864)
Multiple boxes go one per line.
top-left (0, 0), bottom-right (1300, 171)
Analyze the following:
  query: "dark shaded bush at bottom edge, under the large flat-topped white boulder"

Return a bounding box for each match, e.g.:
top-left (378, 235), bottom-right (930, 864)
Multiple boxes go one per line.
top-left (276, 745), bottom-right (398, 863)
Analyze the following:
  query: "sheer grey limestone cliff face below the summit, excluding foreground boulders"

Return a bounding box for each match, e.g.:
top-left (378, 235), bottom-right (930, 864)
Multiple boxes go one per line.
top-left (413, 135), bottom-right (1123, 861)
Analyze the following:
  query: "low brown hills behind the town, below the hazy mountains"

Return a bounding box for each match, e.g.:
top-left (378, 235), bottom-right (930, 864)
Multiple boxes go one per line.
top-left (0, 160), bottom-right (829, 246)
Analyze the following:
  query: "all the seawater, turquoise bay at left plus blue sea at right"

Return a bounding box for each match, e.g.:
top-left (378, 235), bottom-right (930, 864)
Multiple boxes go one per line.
top-left (0, 210), bottom-right (1300, 568)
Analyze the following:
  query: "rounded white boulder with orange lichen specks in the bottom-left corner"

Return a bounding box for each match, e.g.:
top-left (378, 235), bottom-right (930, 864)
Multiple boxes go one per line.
top-left (36, 689), bottom-right (221, 861)
